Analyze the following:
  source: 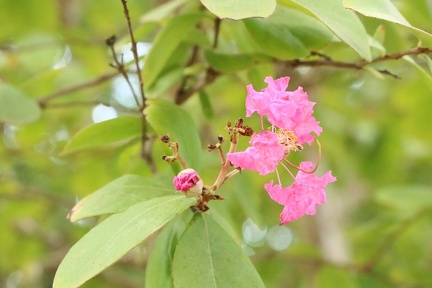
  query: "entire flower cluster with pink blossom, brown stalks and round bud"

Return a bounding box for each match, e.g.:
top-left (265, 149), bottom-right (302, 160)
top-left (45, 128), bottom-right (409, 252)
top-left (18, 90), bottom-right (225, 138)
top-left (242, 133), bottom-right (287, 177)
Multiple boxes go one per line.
top-left (167, 77), bottom-right (336, 224)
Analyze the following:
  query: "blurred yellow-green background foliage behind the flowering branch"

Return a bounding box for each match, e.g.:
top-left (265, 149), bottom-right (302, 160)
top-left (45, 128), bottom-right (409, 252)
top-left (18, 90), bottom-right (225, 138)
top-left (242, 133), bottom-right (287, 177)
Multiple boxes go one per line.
top-left (0, 0), bottom-right (432, 288)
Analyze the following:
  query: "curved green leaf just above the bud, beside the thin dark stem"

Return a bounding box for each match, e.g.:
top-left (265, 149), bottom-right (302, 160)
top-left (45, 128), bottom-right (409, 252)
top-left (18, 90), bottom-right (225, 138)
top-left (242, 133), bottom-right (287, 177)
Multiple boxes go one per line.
top-left (144, 99), bottom-right (201, 170)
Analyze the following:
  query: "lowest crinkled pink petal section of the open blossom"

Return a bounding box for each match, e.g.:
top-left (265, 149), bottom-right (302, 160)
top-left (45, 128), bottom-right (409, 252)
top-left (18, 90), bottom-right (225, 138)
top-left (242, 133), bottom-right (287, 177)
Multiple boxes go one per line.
top-left (264, 161), bottom-right (336, 225)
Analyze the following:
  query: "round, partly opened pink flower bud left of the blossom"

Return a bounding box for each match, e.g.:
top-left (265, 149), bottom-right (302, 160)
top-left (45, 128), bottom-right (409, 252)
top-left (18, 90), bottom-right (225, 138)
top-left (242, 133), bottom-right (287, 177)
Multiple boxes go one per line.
top-left (173, 168), bottom-right (204, 198)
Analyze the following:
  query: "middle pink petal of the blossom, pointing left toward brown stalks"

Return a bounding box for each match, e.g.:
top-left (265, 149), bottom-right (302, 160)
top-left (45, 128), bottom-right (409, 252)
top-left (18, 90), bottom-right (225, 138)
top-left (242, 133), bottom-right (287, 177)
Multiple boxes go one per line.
top-left (227, 131), bottom-right (285, 175)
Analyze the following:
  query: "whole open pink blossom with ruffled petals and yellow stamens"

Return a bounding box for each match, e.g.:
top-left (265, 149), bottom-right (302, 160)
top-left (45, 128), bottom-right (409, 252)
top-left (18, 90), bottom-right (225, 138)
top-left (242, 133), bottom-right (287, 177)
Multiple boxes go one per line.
top-left (227, 77), bottom-right (336, 224)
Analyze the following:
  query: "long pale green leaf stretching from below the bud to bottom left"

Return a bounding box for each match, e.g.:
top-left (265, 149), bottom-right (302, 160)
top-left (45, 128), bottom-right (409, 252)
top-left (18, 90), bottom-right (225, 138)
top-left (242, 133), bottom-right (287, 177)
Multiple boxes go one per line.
top-left (53, 195), bottom-right (196, 288)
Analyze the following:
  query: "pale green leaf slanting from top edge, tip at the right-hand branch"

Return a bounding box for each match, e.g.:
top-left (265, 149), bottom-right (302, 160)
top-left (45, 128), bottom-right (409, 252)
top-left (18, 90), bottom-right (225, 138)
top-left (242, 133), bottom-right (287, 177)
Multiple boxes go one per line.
top-left (293, 0), bottom-right (372, 61)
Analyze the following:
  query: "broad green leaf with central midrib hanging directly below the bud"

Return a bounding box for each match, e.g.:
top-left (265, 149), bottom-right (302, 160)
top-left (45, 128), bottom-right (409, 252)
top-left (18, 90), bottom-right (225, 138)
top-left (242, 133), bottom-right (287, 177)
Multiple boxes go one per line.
top-left (172, 214), bottom-right (264, 288)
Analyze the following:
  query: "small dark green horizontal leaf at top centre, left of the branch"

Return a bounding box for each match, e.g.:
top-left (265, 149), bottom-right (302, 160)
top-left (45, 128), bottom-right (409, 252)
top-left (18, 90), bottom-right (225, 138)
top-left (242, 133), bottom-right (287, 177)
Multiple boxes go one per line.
top-left (204, 50), bottom-right (254, 72)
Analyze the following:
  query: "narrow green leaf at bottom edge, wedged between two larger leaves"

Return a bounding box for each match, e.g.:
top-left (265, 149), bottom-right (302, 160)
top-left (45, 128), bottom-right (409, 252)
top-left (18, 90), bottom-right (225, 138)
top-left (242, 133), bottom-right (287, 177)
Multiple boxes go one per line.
top-left (144, 209), bottom-right (193, 288)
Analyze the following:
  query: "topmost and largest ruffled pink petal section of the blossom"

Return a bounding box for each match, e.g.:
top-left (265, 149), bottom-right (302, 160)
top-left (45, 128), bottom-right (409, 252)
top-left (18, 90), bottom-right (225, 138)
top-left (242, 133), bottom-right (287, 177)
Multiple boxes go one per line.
top-left (246, 76), bottom-right (322, 144)
